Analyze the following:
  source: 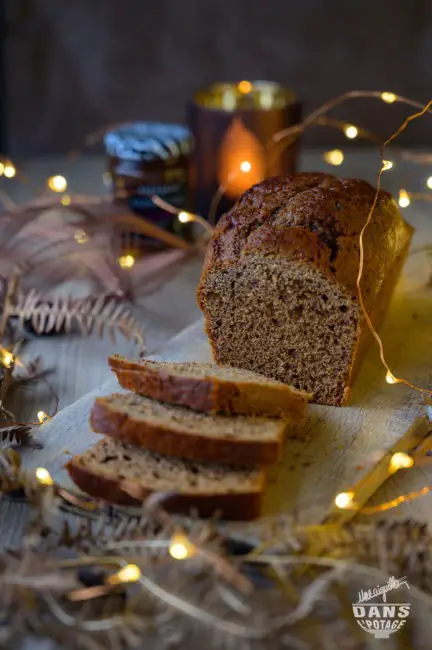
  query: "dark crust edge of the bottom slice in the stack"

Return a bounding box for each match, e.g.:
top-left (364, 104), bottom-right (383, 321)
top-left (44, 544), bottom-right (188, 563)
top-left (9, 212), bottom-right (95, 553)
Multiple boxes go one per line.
top-left (66, 459), bottom-right (262, 521)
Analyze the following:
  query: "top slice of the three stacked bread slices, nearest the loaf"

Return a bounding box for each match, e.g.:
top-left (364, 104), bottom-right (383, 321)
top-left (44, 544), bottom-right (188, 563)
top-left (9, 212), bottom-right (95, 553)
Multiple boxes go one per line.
top-left (108, 355), bottom-right (312, 420)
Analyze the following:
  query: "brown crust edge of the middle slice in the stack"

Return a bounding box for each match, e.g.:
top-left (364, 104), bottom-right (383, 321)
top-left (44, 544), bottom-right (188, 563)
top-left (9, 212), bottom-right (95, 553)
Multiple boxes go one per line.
top-left (90, 397), bottom-right (284, 465)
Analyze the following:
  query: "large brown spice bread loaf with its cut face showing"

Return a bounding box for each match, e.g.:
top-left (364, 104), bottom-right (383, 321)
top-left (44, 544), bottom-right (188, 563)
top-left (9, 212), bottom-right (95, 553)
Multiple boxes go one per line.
top-left (197, 173), bottom-right (413, 405)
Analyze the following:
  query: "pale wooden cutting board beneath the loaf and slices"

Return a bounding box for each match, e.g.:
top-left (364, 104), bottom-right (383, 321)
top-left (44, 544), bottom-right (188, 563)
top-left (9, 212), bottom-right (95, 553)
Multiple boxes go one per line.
top-left (20, 251), bottom-right (432, 523)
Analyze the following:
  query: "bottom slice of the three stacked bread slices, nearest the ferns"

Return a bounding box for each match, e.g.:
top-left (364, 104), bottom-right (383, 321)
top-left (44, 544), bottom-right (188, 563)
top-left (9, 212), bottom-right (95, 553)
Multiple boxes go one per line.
top-left (67, 438), bottom-right (265, 520)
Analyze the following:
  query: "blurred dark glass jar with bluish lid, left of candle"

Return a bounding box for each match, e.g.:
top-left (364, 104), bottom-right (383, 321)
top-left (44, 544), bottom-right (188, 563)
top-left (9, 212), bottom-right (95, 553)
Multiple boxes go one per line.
top-left (105, 122), bottom-right (192, 248)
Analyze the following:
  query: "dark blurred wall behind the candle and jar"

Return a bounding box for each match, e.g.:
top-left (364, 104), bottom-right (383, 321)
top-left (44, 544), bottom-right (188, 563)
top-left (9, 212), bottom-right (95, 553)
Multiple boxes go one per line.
top-left (4, 0), bottom-right (432, 155)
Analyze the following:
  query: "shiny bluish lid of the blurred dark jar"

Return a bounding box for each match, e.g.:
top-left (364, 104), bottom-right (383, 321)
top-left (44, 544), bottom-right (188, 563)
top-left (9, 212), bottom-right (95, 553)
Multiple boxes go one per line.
top-left (104, 122), bottom-right (192, 160)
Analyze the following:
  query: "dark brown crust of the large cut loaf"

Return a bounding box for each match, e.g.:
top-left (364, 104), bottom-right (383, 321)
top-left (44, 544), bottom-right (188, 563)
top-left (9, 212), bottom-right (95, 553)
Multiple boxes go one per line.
top-left (197, 173), bottom-right (413, 403)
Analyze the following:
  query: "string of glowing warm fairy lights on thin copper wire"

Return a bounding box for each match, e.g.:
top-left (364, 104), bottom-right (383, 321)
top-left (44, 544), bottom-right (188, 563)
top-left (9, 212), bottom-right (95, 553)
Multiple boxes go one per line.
top-left (0, 88), bottom-right (432, 520)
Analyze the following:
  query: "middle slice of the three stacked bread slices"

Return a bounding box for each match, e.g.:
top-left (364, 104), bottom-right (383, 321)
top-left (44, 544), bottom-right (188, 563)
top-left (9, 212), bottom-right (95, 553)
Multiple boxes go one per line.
top-left (90, 393), bottom-right (287, 465)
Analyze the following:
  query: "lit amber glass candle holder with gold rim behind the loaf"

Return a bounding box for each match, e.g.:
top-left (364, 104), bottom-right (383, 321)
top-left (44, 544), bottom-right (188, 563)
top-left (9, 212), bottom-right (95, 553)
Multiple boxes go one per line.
top-left (188, 81), bottom-right (301, 217)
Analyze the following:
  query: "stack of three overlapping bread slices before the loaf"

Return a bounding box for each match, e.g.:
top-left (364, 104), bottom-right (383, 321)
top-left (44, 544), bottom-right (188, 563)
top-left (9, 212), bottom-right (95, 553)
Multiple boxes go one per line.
top-left (67, 355), bottom-right (311, 520)
